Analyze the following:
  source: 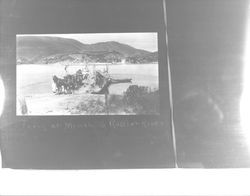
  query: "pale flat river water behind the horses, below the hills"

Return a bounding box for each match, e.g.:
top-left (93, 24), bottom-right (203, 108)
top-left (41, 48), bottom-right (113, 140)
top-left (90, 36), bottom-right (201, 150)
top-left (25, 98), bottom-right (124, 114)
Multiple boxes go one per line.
top-left (17, 64), bottom-right (159, 96)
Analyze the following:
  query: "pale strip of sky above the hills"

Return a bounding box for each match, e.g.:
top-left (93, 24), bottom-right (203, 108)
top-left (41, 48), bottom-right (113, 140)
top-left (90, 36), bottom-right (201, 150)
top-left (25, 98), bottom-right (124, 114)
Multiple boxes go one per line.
top-left (19, 32), bottom-right (158, 52)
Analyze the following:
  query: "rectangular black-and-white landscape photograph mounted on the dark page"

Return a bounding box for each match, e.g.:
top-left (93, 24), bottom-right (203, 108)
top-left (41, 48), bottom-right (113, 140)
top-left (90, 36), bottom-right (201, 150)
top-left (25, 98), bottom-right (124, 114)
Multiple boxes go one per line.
top-left (16, 32), bottom-right (159, 116)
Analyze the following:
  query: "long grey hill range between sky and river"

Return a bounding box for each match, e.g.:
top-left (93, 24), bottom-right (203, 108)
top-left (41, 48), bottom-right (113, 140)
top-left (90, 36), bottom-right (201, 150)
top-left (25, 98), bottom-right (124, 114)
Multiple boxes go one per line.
top-left (17, 36), bottom-right (158, 64)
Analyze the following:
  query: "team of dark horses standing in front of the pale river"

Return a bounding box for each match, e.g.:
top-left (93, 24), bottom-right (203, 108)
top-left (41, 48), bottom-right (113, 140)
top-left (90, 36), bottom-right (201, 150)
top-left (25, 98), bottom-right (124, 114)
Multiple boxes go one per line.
top-left (52, 69), bottom-right (88, 94)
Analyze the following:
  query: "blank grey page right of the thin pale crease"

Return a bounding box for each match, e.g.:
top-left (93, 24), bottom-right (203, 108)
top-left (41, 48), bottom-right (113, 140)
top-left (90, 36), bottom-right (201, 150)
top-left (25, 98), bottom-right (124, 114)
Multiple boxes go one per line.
top-left (167, 0), bottom-right (250, 167)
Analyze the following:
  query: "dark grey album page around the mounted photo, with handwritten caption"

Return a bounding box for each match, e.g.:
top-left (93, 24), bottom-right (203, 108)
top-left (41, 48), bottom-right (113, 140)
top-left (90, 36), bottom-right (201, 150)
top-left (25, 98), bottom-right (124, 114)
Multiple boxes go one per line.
top-left (1, 0), bottom-right (174, 169)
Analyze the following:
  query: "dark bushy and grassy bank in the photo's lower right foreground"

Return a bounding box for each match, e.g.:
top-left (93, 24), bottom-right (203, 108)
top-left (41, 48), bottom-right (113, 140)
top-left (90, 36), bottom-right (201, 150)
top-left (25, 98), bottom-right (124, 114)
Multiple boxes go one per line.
top-left (71, 85), bottom-right (159, 115)
